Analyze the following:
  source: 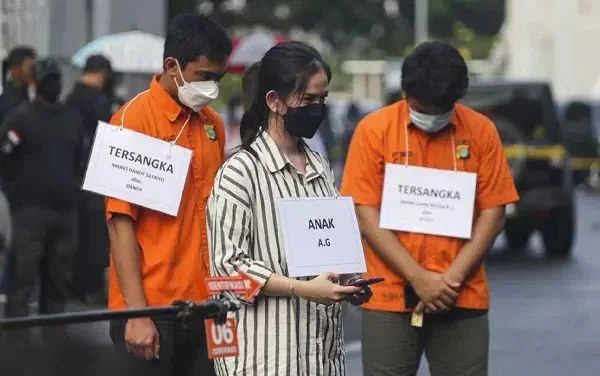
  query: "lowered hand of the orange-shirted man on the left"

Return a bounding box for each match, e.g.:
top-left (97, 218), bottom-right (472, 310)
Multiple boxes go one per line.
top-left (125, 318), bottom-right (160, 360)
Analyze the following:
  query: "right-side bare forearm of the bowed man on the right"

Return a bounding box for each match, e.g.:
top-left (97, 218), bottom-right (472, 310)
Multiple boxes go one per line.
top-left (447, 207), bottom-right (504, 283)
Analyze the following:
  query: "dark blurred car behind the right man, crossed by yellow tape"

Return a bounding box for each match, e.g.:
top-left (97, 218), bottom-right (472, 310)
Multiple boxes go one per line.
top-left (463, 81), bottom-right (576, 257)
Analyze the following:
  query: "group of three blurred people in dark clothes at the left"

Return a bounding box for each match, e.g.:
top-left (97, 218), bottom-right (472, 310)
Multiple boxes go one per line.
top-left (0, 46), bottom-right (114, 317)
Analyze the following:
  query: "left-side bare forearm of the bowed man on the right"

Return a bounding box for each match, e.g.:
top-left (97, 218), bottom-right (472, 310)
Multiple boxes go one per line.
top-left (356, 205), bottom-right (422, 281)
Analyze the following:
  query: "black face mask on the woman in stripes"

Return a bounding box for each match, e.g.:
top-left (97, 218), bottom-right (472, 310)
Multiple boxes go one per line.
top-left (283, 103), bottom-right (326, 138)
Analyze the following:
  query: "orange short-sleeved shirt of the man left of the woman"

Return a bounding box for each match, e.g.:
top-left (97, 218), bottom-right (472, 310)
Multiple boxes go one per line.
top-left (106, 76), bottom-right (225, 309)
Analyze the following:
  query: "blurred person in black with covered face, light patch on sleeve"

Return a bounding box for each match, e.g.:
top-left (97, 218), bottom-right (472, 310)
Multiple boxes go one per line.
top-left (0, 59), bottom-right (86, 317)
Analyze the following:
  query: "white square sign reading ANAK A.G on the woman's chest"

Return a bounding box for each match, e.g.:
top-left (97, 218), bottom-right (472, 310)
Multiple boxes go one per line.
top-left (278, 197), bottom-right (366, 277)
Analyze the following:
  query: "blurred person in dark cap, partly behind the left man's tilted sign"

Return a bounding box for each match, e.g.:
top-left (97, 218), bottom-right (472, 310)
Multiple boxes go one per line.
top-left (66, 55), bottom-right (114, 304)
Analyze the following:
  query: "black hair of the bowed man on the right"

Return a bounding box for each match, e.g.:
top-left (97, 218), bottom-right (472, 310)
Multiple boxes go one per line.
top-left (402, 42), bottom-right (469, 110)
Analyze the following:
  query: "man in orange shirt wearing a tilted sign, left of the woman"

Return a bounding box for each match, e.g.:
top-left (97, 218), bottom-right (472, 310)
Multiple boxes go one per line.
top-left (106, 14), bottom-right (231, 375)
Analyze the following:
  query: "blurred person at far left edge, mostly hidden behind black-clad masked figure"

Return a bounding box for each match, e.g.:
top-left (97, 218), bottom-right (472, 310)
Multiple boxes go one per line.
top-left (0, 46), bottom-right (36, 313)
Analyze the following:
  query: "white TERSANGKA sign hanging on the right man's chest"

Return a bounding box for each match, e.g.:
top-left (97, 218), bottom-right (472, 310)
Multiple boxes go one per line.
top-left (379, 164), bottom-right (477, 239)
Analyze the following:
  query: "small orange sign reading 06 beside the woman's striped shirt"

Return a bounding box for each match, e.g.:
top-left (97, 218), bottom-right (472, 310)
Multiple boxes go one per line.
top-left (204, 317), bottom-right (239, 359)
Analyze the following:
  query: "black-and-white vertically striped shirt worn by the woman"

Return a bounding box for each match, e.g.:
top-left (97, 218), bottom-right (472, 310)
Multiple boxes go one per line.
top-left (207, 132), bottom-right (345, 376)
